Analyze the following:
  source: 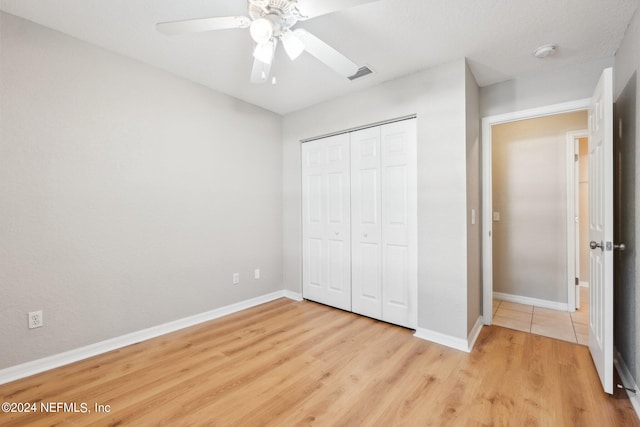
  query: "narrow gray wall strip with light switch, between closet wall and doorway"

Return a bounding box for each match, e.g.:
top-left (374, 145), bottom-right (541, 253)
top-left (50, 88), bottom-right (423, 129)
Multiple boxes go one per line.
top-left (465, 61), bottom-right (482, 332)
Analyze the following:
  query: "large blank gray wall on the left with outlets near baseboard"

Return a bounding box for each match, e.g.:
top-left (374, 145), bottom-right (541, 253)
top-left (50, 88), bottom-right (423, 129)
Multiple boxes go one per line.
top-left (0, 13), bottom-right (282, 368)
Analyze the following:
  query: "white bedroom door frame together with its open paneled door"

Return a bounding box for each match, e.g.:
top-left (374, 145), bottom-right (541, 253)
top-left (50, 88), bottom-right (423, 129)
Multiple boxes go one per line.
top-left (482, 68), bottom-right (624, 394)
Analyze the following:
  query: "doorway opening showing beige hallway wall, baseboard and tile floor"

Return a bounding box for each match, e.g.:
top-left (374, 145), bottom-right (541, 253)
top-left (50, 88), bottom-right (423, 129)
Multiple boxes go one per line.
top-left (492, 110), bottom-right (588, 344)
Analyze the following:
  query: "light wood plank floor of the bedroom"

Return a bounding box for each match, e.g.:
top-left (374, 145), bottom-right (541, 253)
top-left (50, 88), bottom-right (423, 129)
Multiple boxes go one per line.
top-left (0, 299), bottom-right (640, 427)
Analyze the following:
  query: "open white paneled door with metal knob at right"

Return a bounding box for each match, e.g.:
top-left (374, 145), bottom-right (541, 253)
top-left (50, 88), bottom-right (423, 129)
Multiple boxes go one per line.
top-left (589, 68), bottom-right (613, 394)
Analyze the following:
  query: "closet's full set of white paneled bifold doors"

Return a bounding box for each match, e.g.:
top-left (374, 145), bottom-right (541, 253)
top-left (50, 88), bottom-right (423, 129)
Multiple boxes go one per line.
top-left (302, 119), bottom-right (417, 328)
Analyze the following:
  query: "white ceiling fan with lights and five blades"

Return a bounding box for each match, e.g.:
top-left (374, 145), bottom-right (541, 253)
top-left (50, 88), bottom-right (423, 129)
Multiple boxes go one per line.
top-left (156, 0), bottom-right (375, 83)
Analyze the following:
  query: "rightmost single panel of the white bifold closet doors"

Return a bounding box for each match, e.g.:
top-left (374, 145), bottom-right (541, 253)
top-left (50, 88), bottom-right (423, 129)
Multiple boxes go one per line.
top-left (380, 119), bottom-right (418, 328)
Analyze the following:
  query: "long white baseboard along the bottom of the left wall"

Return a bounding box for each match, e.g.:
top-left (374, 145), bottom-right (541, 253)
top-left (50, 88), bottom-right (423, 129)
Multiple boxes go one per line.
top-left (0, 290), bottom-right (302, 384)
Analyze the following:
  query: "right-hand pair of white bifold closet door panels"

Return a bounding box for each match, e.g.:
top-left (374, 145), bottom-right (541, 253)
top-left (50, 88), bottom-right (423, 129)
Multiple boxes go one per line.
top-left (351, 120), bottom-right (418, 328)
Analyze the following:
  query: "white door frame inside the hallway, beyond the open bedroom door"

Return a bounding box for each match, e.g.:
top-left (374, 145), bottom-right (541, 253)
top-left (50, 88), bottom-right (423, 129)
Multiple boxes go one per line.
top-left (567, 129), bottom-right (589, 313)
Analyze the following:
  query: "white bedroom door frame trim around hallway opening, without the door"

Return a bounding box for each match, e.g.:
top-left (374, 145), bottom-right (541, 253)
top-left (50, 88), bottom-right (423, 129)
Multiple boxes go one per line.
top-left (482, 98), bottom-right (591, 325)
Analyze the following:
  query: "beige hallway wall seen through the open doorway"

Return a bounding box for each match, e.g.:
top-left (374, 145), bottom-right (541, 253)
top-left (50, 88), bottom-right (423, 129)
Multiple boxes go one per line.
top-left (492, 111), bottom-right (587, 303)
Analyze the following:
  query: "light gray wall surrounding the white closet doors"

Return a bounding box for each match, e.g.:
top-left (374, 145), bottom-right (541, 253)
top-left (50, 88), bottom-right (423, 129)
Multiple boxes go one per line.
top-left (283, 60), bottom-right (475, 339)
